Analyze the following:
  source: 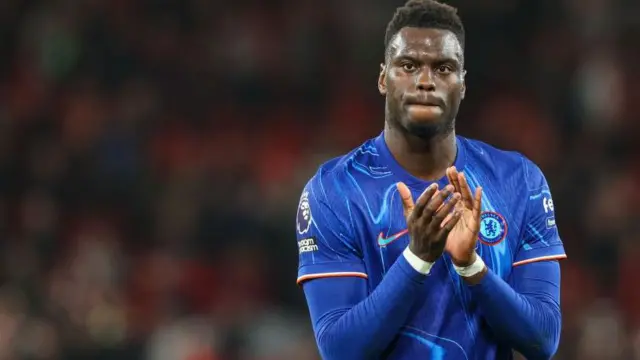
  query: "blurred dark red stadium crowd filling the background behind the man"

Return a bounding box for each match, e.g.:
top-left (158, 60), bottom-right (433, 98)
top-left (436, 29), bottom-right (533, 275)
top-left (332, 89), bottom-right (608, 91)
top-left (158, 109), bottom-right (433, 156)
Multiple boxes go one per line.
top-left (0, 0), bottom-right (640, 360)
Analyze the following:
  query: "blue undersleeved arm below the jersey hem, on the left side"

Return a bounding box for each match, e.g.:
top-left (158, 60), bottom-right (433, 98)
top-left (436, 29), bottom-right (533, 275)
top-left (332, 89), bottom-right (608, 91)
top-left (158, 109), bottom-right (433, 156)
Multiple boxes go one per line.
top-left (304, 256), bottom-right (426, 360)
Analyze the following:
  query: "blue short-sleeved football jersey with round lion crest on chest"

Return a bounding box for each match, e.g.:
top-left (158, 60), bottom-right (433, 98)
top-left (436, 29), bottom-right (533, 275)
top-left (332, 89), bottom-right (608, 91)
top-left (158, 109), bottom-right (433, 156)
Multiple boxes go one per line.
top-left (296, 134), bottom-right (566, 359)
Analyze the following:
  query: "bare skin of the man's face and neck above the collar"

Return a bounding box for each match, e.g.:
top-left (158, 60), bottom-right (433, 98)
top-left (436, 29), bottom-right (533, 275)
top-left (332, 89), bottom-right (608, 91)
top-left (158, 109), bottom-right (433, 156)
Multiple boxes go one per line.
top-left (378, 27), bottom-right (466, 180)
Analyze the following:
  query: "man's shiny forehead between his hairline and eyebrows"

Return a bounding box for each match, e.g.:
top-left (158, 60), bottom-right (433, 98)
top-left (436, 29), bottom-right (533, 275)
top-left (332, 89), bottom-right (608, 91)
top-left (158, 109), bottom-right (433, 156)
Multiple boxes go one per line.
top-left (389, 27), bottom-right (462, 60)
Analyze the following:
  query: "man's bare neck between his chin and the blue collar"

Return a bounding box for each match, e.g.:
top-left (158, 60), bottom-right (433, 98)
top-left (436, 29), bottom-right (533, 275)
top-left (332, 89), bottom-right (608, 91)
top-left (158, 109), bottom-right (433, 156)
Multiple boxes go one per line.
top-left (384, 123), bottom-right (457, 181)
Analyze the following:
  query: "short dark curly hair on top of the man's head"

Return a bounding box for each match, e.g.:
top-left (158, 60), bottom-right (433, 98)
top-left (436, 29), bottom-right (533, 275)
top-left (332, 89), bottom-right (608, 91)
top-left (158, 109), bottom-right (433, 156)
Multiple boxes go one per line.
top-left (384, 0), bottom-right (464, 55)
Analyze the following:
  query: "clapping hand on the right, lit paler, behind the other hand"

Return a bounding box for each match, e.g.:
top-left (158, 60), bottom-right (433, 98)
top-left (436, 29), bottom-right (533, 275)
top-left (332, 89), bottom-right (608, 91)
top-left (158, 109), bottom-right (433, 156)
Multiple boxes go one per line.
top-left (442, 166), bottom-right (482, 267)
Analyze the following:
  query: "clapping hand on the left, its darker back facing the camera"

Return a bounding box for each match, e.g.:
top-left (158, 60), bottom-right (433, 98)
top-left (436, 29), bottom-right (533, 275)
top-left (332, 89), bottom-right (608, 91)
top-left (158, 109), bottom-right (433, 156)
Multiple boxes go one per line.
top-left (397, 182), bottom-right (461, 262)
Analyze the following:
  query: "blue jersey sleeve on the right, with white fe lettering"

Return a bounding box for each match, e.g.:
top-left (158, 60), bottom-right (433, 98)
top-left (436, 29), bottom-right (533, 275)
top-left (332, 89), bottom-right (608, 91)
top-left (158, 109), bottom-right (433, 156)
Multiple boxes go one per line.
top-left (513, 158), bottom-right (567, 266)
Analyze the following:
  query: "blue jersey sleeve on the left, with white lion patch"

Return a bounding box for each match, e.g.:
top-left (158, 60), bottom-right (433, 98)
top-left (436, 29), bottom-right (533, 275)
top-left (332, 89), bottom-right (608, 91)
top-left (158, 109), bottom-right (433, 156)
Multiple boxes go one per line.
top-left (296, 175), bottom-right (367, 285)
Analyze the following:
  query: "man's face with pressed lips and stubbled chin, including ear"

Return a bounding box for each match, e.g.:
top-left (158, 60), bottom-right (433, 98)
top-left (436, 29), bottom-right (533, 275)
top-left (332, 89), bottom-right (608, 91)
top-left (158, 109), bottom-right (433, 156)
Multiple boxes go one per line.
top-left (378, 27), bottom-right (465, 138)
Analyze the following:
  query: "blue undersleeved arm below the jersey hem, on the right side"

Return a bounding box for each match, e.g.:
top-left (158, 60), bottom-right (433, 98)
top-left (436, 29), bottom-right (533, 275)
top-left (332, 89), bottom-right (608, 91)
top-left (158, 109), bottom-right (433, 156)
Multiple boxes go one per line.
top-left (471, 262), bottom-right (561, 359)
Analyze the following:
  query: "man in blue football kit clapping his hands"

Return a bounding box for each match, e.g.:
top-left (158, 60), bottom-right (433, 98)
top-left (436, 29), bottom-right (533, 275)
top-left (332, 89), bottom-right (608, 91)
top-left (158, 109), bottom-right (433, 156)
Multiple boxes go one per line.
top-left (296, 0), bottom-right (566, 360)
